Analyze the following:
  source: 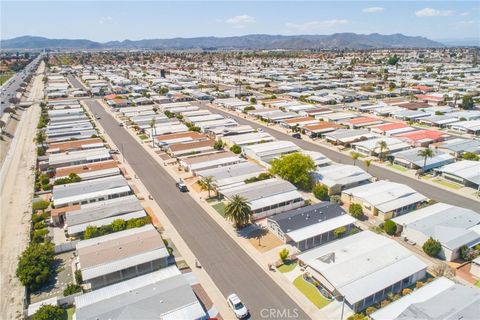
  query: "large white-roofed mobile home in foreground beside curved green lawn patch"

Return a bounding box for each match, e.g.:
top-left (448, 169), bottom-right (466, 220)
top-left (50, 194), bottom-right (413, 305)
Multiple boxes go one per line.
top-left (298, 231), bottom-right (427, 312)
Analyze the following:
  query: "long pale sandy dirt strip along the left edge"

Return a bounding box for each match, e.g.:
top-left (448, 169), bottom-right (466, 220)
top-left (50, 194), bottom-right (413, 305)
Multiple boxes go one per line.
top-left (0, 63), bottom-right (44, 319)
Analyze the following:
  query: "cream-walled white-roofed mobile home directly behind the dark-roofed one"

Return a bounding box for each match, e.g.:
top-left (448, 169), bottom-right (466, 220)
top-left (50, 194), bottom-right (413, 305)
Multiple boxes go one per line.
top-left (342, 180), bottom-right (428, 220)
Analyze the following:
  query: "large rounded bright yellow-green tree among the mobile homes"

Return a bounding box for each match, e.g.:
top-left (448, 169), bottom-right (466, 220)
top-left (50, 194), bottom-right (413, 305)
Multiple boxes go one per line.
top-left (270, 152), bottom-right (315, 190)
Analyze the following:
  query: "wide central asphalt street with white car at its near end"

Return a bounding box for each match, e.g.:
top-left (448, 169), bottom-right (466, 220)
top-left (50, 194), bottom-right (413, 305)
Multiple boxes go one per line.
top-left (85, 100), bottom-right (308, 319)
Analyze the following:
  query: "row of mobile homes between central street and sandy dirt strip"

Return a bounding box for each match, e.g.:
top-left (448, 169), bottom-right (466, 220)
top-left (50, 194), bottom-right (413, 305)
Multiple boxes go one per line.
top-left (31, 97), bottom-right (208, 320)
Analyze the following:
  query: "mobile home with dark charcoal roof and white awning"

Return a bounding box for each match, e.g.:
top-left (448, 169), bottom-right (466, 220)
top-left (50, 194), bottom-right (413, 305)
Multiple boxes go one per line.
top-left (267, 202), bottom-right (356, 251)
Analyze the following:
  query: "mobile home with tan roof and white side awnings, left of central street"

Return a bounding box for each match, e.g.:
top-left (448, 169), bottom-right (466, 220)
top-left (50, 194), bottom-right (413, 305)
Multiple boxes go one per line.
top-left (76, 224), bottom-right (169, 290)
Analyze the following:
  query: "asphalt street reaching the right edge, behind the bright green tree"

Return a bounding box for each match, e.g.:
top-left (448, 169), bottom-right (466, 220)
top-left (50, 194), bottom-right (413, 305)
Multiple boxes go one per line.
top-left (201, 103), bottom-right (480, 212)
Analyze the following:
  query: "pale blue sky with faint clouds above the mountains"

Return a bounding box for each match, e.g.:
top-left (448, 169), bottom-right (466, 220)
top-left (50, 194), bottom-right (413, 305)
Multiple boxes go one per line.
top-left (0, 0), bottom-right (480, 41)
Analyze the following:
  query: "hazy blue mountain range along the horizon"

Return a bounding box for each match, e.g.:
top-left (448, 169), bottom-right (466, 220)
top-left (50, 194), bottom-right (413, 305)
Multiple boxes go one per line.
top-left (0, 33), bottom-right (444, 50)
